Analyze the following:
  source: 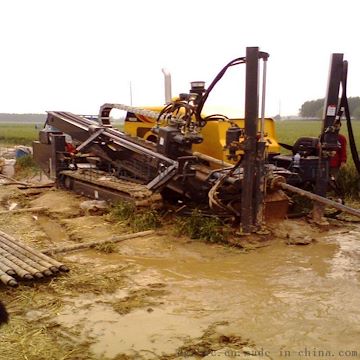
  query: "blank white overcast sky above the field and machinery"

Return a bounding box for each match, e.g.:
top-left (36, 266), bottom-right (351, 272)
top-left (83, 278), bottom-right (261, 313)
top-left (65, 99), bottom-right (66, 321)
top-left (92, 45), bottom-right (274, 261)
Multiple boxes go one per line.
top-left (0, 0), bottom-right (360, 116)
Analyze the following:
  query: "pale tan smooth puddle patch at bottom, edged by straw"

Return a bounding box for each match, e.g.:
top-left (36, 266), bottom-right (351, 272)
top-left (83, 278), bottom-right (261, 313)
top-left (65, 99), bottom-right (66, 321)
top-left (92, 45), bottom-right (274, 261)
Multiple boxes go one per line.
top-left (58, 301), bottom-right (204, 359)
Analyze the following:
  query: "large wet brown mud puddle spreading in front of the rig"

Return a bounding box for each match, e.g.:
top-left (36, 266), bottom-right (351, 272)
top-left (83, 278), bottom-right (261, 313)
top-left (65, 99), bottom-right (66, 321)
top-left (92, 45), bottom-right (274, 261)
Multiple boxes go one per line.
top-left (54, 226), bottom-right (360, 359)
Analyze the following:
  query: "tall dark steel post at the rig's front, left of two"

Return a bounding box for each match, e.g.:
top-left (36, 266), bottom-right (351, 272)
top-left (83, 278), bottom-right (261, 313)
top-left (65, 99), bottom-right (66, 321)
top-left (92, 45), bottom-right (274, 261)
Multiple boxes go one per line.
top-left (241, 47), bottom-right (259, 233)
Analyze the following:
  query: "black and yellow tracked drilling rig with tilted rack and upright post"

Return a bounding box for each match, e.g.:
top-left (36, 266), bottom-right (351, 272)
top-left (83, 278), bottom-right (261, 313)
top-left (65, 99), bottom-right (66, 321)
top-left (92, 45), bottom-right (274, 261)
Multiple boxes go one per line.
top-left (33, 47), bottom-right (360, 233)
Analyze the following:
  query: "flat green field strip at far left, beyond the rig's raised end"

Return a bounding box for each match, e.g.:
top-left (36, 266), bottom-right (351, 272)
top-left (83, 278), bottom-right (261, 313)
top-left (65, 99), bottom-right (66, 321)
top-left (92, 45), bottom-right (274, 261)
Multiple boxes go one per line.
top-left (0, 123), bottom-right (41, 145)
